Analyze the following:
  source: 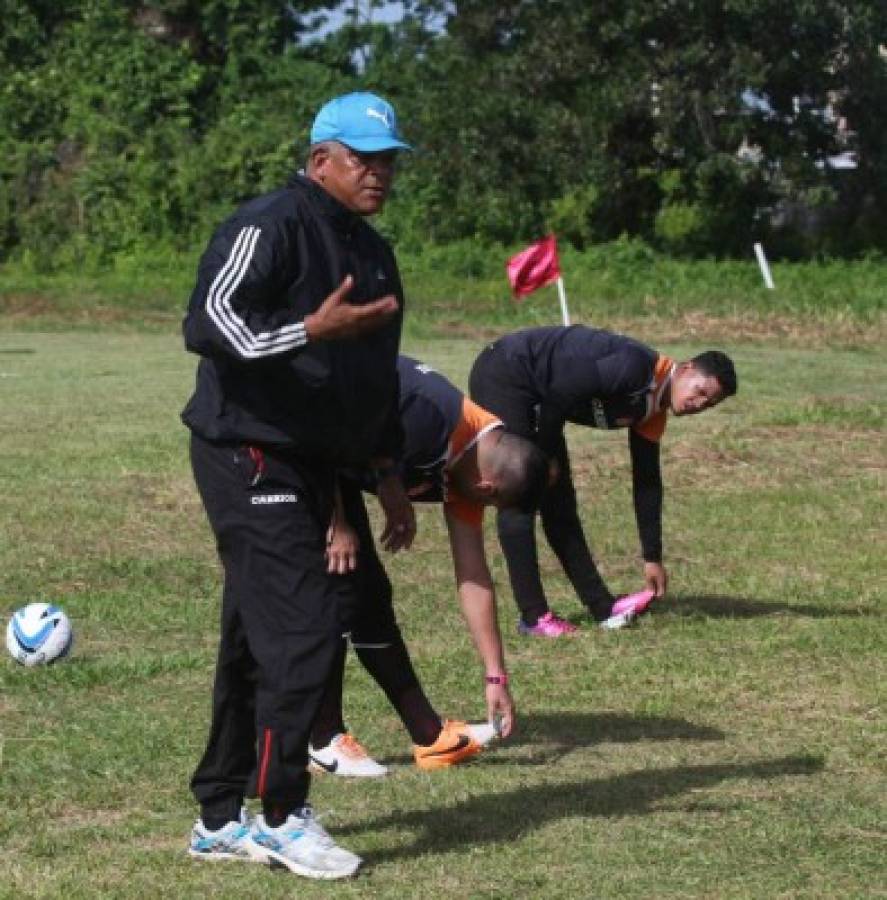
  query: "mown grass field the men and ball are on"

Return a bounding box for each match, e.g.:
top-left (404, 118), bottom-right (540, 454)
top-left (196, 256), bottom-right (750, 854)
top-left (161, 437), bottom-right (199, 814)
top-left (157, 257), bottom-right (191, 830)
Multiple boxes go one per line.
top-left (0, 320), bottom-right (887, 898)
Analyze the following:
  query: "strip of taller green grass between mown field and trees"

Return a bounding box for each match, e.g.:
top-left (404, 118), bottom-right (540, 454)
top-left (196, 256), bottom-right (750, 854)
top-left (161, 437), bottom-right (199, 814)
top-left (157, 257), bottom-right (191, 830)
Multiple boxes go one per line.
top-left (0, 240), bottom-right (887, 346)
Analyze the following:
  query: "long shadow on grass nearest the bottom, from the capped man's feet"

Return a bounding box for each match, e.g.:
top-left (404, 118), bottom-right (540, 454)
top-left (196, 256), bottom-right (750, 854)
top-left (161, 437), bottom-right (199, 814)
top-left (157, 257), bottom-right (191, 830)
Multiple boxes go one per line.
top-left (350, 755), bottom-right (823, 863)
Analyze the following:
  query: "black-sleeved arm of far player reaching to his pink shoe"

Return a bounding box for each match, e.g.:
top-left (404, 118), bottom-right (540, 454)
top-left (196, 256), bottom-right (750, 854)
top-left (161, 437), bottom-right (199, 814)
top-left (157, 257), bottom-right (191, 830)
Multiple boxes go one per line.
top-left (628, 428), bottom-right (668, 597)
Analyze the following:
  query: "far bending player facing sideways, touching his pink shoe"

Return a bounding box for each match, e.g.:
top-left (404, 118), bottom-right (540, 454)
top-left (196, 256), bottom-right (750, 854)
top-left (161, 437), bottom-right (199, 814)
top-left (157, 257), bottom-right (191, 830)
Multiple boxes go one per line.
top-left (469, 325), bottom-right (736, 637)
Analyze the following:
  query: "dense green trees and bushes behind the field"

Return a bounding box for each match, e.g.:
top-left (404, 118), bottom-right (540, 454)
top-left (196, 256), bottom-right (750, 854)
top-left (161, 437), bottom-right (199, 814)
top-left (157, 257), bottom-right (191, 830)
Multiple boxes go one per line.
top-left (0, 0), bottom-right (887, 271)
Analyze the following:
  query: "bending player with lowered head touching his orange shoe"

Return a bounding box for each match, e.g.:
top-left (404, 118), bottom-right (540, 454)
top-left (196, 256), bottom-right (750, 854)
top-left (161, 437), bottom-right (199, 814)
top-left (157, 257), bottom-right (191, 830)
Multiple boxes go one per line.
top-left (309, 356), bottom-right (549, 776)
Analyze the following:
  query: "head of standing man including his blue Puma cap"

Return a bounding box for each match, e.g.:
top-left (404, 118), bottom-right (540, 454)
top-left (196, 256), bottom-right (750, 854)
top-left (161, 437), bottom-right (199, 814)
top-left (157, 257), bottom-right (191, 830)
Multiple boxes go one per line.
top-left (308, 91), bottom-right (412, 216)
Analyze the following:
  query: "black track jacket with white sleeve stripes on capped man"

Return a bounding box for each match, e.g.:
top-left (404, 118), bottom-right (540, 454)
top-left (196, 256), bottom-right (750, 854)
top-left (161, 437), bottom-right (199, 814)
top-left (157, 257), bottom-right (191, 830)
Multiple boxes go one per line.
top-left (182, 175), bottom-right (403, 465)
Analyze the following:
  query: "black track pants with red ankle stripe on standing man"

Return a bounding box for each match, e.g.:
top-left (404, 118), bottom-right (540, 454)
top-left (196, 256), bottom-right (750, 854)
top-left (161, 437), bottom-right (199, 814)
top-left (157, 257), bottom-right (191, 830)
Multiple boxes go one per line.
top-left (191, 436), bottom-right (357, 818)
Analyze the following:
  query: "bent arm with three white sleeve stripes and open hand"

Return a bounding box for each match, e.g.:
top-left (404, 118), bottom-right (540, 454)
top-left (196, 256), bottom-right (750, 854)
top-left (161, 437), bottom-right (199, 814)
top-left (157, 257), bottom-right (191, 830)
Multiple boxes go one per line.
top-left (184, 221), bottom-right (397, 362)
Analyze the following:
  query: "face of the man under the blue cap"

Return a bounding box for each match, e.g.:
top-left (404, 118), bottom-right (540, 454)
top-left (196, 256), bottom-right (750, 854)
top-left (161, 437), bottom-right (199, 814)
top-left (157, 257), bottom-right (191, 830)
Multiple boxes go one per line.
top-left (313, 143), bottom-right (397, 216)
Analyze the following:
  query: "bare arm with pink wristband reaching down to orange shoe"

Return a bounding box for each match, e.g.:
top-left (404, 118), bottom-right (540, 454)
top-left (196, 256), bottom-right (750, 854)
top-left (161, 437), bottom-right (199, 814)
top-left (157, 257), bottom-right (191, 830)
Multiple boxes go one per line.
top-left (444, 506), bottom-right (514, 737)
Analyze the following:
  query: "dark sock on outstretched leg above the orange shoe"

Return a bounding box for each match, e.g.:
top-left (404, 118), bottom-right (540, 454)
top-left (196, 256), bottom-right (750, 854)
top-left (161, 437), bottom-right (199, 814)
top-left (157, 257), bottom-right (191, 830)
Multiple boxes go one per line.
top-left (354, 635), bottom-right (443, 746)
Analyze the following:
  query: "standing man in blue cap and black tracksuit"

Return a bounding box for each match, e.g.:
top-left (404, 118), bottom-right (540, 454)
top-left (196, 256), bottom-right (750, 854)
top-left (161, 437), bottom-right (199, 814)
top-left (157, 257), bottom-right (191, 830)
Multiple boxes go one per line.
top-left (182, 93), bottom-right (415, 878)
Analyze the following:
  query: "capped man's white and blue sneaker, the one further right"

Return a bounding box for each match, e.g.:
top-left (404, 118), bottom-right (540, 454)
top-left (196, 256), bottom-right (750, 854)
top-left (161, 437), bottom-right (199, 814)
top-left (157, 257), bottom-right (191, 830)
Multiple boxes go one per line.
top-left (250, 806), bottom-right (363, 878)
